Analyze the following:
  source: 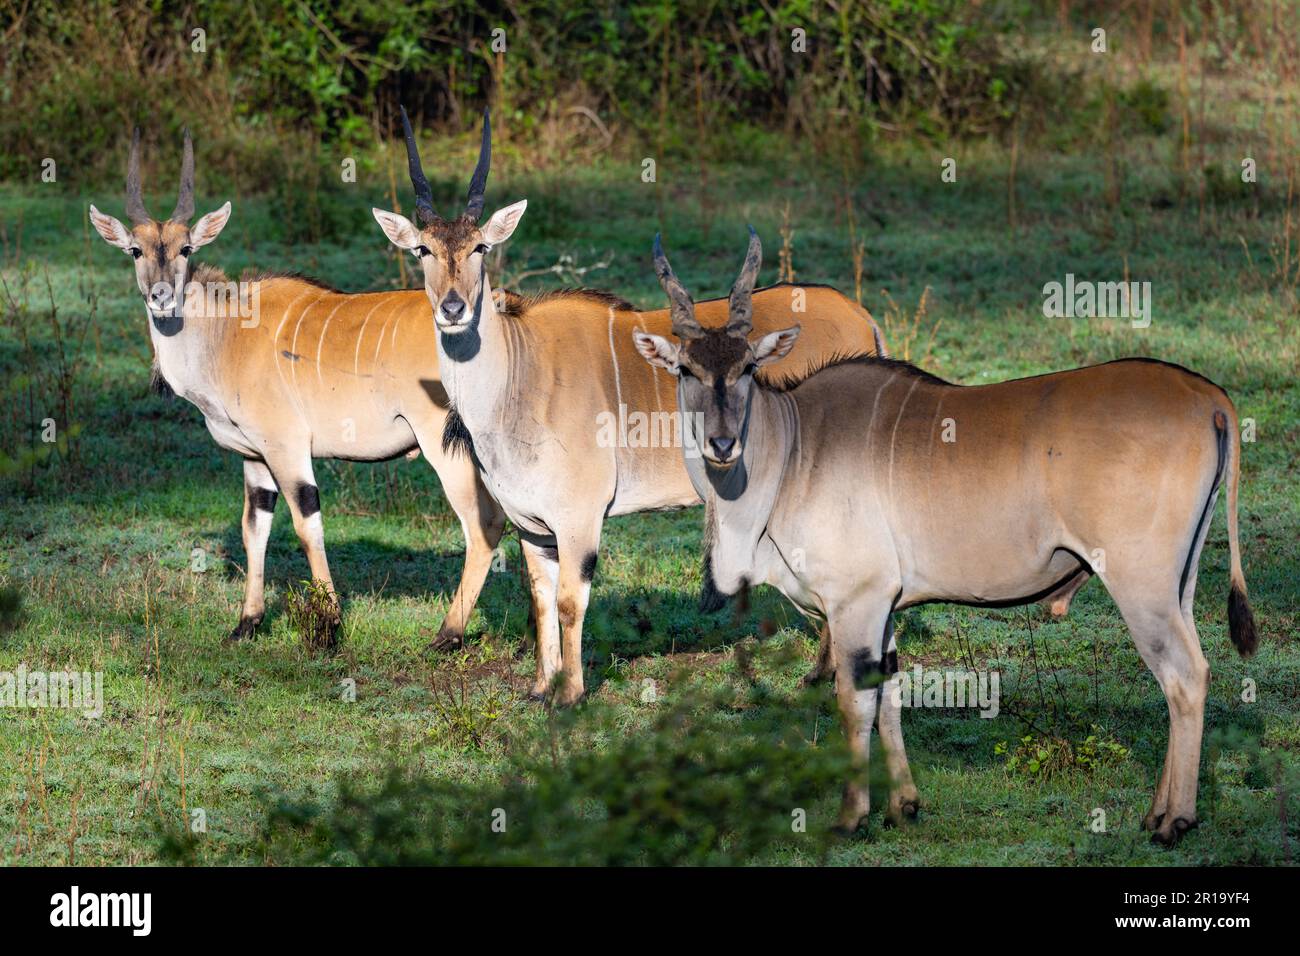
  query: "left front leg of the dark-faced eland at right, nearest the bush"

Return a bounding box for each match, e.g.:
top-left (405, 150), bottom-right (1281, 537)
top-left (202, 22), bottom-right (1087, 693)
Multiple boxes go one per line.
top-left (828, 606), bottom-right (891, 834)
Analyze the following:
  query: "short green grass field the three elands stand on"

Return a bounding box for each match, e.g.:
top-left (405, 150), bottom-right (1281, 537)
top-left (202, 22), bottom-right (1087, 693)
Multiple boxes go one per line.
top-left (0, 128), bottom-right (1300, 865)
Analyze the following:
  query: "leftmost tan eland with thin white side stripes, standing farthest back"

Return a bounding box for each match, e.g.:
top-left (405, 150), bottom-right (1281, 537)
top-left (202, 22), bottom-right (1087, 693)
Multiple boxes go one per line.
top-left (90, 130), bottom-right (504, 643)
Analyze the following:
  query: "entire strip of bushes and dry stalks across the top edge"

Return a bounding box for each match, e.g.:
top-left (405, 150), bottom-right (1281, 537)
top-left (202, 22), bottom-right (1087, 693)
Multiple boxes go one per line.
top-left (0, 0), bottom-right (1297, 180)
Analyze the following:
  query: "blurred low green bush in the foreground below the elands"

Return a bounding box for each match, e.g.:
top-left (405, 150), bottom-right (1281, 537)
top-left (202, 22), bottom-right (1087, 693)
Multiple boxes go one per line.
top-left (226, 650), bottom-right (849, 866)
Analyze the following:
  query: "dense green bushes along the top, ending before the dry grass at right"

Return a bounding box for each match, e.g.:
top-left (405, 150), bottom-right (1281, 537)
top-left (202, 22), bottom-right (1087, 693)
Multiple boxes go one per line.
top-left (0, 0), bottom-right (1055, 187)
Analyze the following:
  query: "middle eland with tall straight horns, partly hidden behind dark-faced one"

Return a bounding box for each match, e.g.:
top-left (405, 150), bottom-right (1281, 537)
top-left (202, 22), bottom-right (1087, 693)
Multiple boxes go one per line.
top-left (373, 111), bottom-right (883, 705)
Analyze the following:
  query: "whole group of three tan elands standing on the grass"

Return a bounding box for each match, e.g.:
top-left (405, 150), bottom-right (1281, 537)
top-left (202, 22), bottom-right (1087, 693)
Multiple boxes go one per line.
top-left (90, 111), bottom-right (1256, 844)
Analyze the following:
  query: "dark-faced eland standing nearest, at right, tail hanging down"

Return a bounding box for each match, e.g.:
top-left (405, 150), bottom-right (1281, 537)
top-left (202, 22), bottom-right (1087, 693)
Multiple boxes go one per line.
top-left (634, 230), bottom-right (1256, 845)
